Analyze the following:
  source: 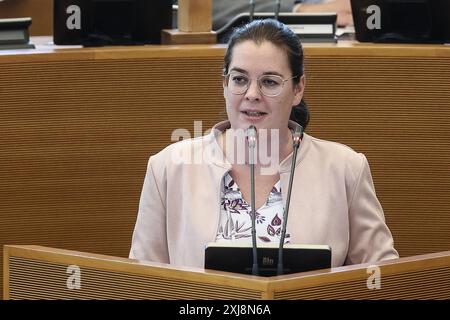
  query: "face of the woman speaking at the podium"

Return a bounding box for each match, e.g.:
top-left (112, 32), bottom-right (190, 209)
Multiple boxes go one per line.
top-left (224, 40), bottom-right (304, 130)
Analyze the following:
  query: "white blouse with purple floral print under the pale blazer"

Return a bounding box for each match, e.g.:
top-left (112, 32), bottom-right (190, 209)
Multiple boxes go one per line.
top-left (216, 173), bottom-right (290, 243)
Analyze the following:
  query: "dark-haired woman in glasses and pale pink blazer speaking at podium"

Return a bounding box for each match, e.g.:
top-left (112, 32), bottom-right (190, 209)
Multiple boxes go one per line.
top-left (130, 19), bottom-right (398, 268)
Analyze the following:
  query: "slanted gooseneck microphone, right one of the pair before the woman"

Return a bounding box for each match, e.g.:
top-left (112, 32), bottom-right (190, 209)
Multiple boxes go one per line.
top-left (277, 125), bottom-right (303, 275)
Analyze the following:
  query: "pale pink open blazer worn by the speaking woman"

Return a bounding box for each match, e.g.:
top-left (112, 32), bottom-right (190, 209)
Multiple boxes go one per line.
top-left (130, 121), bottom-right (398, 268)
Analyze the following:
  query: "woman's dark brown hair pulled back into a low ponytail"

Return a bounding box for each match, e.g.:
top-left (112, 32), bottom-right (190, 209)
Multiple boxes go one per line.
top-left (223, 19), bottom-right (309, 129)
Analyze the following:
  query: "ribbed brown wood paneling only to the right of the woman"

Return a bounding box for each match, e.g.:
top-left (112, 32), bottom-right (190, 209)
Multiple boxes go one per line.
top-left (306, 56), bottom-right (450, 256)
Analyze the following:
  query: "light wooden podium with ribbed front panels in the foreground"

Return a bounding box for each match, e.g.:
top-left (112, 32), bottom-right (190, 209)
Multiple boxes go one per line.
top-left (3, 245), bottom-right (450, 300)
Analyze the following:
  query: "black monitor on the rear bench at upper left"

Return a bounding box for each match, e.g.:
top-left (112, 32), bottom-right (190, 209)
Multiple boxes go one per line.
top-left (53, 0), bottom-right (172, 46)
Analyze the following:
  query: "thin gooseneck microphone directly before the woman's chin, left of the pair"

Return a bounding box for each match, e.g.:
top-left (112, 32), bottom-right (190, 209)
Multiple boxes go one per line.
top-left (247, 125), bottom-right (259, 276)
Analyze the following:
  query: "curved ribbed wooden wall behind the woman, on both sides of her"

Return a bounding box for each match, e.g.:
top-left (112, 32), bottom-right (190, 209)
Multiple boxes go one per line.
top-left (0, 42), bottom-right (450, 298)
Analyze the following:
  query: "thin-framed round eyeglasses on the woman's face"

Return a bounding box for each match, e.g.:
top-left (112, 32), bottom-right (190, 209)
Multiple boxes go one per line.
top-left (223, 71), bottom-right (298, 97)
